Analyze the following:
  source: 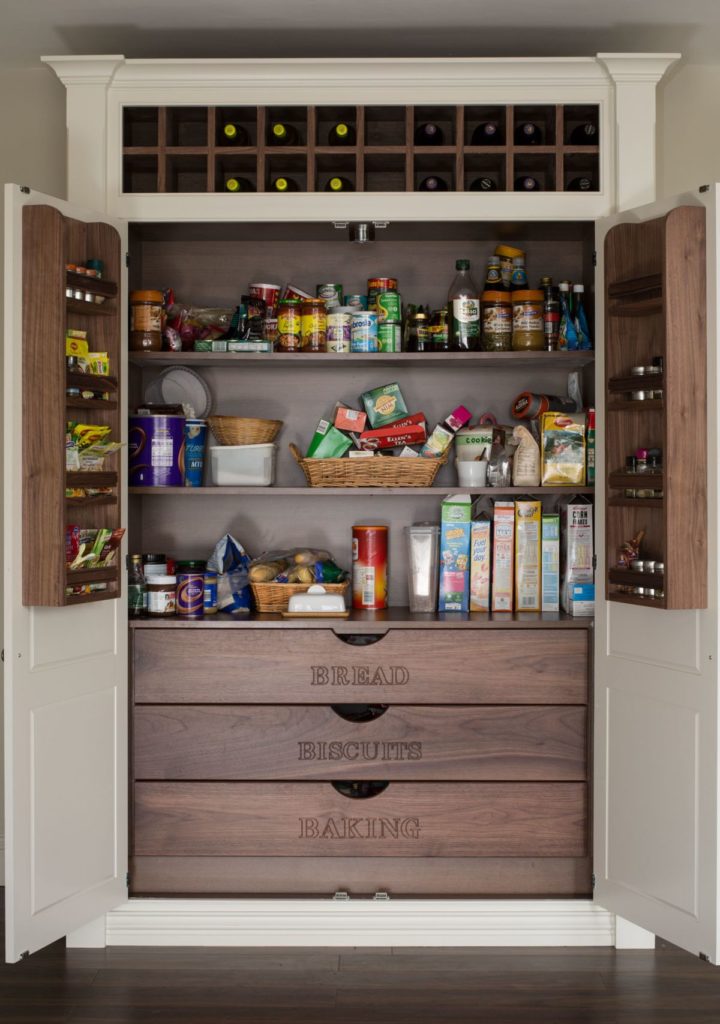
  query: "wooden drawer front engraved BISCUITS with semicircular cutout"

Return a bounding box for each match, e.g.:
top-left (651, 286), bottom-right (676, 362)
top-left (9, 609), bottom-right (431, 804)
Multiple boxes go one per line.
top-left (134, 705), bottom-right (586, 781)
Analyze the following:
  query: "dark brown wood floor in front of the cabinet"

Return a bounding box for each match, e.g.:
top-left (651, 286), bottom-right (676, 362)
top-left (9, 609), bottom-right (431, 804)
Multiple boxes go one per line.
top-left (0, 890), bottom-right (720, 1024)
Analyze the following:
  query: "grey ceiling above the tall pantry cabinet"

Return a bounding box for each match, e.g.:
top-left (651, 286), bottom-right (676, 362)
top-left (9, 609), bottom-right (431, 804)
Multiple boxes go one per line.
top-left (0, 0), bottom-right (720, 67)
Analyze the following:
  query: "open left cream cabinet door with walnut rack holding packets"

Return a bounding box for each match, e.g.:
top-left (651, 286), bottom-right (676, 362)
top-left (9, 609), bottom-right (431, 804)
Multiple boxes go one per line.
top-left (3, 185), bottom-right (127, 963)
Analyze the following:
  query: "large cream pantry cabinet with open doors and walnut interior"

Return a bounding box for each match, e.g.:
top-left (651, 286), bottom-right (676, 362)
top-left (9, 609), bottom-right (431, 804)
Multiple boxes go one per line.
top-left (6, 55), bottom-right (718, 961)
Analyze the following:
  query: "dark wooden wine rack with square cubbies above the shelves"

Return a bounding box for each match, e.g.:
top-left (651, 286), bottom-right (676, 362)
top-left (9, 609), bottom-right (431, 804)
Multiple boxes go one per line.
top-left (123, 104), bottom-right (600, 193)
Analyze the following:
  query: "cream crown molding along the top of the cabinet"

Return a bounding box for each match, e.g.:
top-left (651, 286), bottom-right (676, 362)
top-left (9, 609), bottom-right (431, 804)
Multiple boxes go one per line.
top-left (41, 53), bottom-right (680, 89)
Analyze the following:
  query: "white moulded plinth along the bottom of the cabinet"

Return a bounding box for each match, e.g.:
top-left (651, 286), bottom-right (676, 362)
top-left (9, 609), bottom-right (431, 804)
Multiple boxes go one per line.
top-left (107, 899), bottom-right (615, 946)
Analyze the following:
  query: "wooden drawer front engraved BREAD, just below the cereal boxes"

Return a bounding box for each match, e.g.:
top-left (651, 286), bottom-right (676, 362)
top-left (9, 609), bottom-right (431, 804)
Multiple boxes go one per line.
top-left (133, 629), bottom-right (588, 705)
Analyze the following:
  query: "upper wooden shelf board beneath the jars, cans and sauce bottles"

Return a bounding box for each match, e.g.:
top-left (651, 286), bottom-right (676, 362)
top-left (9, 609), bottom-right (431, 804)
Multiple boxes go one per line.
top-left (128, 351), bottom-right (595, 371)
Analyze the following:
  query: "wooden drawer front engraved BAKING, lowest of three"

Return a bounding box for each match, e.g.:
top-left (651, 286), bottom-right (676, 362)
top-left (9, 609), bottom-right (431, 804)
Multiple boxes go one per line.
top-left (134, 782), bottom-right (587, 857)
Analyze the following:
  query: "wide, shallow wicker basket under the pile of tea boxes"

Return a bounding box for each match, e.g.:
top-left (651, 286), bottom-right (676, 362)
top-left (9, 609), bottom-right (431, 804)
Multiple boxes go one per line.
top-left (290, 444), bottom-right (448, 487)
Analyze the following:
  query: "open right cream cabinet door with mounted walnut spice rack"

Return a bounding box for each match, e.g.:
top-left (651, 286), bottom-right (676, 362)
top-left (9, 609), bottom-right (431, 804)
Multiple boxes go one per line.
top-left (594, 185), bottom-right (720, 964)
